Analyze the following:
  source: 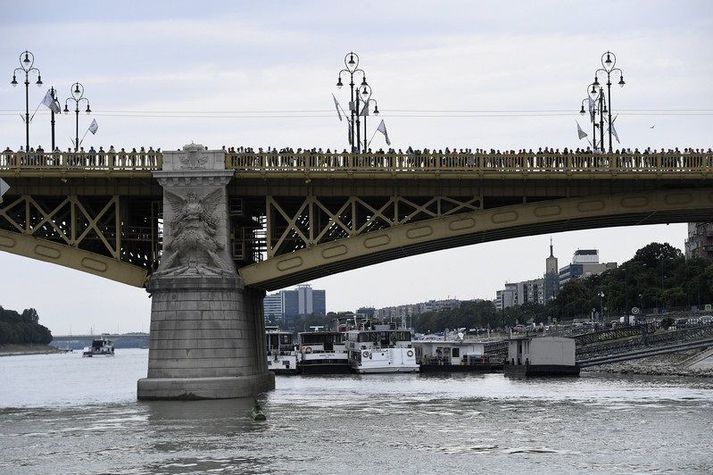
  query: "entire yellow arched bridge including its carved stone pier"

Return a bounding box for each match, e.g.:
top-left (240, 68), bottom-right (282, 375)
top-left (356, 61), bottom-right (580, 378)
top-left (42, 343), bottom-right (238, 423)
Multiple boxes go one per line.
top-left (0, 145), bottom-right (713, 398)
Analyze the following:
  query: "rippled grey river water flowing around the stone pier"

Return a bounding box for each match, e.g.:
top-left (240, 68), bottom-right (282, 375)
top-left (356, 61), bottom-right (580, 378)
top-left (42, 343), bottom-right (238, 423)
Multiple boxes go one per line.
top-left (0, 350), bottom-right (713, 474)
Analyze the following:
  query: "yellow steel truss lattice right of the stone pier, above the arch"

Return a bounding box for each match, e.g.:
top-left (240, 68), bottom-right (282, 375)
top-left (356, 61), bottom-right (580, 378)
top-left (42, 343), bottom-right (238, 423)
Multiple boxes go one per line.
top-left (265, 196), bottom-right (482, 258)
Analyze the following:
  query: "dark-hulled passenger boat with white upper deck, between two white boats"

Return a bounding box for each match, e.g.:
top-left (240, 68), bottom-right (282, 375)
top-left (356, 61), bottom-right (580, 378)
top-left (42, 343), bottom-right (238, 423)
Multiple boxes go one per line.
top-left (297, 331), bottom-right (351, 374)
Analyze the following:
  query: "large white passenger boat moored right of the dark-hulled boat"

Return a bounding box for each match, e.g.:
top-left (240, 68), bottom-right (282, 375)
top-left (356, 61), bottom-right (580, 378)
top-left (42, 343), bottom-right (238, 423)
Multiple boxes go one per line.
top-left (347, 325), bottom-right (419, 373)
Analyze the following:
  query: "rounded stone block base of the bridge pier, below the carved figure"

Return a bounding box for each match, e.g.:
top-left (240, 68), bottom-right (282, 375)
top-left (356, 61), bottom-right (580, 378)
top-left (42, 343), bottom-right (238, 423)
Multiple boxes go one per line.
top-left (137, 276), bottom-right (275, 399)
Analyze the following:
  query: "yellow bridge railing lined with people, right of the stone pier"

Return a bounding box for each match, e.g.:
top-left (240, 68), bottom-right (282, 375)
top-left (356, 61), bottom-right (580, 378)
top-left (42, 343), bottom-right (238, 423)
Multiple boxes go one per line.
top-left (226, 152), bottom-right (713, 174)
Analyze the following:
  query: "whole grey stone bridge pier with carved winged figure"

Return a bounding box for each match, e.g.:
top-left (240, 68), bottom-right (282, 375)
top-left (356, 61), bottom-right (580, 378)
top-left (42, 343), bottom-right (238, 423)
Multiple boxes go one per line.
top-left (137, 145), bottom-right (275, 399)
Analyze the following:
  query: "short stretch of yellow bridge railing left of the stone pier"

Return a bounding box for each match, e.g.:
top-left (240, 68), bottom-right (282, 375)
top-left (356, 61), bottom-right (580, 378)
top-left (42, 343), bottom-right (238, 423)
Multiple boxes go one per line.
top-left (0, 150), bottom-right (163, 171)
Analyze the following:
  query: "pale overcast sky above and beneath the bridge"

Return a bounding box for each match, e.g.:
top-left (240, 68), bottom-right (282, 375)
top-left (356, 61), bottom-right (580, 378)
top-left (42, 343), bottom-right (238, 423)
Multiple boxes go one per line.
top-left (0, 0), bottom-right (713, 334)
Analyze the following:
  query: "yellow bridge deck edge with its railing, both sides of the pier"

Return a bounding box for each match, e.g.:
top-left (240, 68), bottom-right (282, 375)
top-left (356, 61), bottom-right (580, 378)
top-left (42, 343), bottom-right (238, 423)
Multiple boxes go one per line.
top-left (0, 150), bottom-right (713, 179)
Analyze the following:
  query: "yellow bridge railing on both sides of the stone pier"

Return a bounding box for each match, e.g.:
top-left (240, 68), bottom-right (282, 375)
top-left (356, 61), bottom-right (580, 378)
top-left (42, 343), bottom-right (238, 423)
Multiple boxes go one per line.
top-left (0, 149), bottom-right (713, 175)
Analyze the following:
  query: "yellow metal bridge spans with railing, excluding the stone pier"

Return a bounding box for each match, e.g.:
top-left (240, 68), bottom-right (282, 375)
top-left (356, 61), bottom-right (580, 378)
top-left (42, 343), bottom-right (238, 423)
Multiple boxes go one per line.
top-left (0, 149), bottom-right (713, 290)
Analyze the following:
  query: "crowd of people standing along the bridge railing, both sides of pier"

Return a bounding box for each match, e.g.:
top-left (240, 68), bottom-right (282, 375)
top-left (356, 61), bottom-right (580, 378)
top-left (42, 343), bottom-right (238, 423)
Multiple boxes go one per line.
top-left (0, 145), bottom-right (713, 170)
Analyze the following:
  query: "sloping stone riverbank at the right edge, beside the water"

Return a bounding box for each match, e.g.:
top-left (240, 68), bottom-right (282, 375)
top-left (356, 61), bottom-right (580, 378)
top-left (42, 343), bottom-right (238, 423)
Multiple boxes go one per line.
top-left (582, 349), bottom-right (713, 377)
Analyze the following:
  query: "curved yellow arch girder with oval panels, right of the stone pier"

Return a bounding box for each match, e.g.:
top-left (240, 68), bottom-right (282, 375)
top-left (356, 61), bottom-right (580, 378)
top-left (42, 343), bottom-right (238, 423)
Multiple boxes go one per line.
top-left (240, 188), bottom-right (713, 290)
